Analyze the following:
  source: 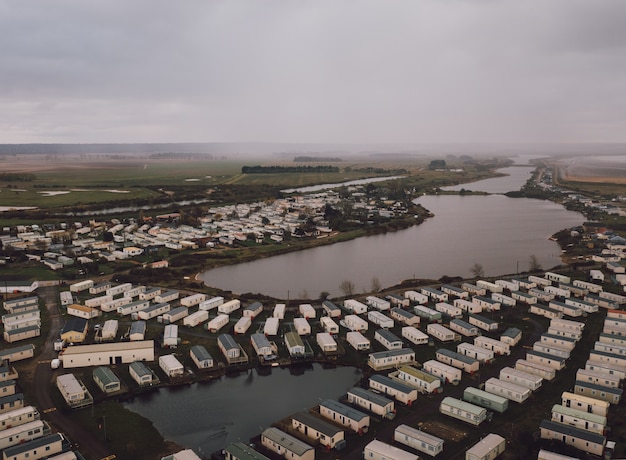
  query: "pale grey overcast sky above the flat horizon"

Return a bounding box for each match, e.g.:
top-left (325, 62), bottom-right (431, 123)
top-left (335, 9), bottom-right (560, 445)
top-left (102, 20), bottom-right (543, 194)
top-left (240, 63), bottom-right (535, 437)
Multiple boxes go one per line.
top-left (0, 0), bottom-right (626, 143)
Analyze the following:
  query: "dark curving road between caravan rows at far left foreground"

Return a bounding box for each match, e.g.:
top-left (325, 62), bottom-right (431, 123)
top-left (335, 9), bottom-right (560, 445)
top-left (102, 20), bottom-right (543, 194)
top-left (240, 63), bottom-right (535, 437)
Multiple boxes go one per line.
top-left (25, 288), bottom-right (113, 460)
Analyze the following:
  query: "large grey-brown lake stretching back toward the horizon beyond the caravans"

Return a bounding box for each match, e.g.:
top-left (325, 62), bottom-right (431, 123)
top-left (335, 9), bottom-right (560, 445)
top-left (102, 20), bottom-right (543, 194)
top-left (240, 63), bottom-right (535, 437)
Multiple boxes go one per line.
top-left (199, 166), bottom-right (585, 299)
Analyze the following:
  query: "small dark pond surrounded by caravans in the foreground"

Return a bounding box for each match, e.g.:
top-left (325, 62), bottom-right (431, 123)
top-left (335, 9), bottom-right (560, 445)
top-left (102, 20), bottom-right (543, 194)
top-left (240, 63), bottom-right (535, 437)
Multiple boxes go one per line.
top-left (125, 364), bottom-right (361, 456)
